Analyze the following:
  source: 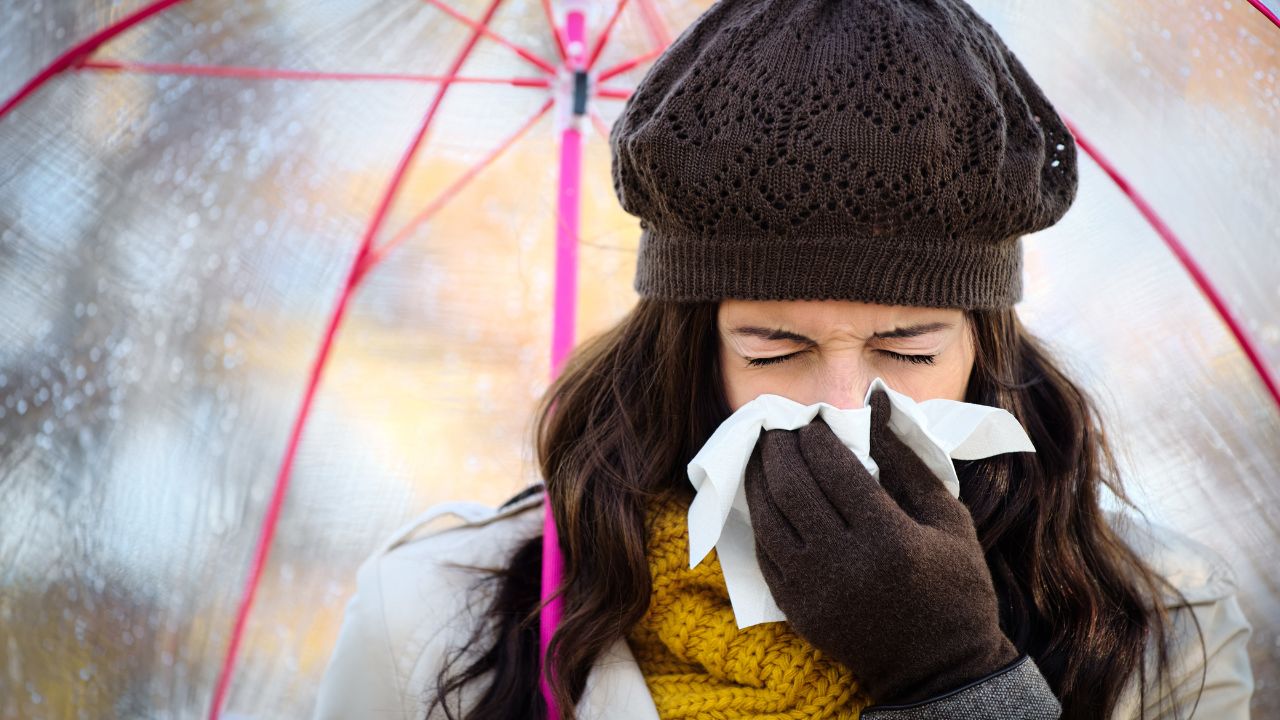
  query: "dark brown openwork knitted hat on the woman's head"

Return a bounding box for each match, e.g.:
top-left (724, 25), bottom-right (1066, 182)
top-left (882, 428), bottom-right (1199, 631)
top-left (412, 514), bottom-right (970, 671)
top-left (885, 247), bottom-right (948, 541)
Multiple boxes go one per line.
top-left (609, 0), bottom-right (1076, 309)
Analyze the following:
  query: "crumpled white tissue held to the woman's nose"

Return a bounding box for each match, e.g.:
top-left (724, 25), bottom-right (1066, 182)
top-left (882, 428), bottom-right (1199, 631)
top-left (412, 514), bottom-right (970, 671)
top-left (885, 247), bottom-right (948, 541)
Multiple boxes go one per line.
top-left (689, 378), bottom-right (1036, 629)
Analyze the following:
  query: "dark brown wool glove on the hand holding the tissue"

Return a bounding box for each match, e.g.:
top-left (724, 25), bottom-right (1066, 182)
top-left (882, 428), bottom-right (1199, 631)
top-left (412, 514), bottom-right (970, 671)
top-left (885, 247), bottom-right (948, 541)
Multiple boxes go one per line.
top-left (746, 389), bottom-right (1019, 705)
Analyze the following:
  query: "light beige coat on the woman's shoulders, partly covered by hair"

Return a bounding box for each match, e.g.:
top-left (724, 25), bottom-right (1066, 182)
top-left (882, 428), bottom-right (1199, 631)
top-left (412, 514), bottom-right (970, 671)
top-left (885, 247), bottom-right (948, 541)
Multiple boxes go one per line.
top-left (314, 484), bottom-right (1253, 720)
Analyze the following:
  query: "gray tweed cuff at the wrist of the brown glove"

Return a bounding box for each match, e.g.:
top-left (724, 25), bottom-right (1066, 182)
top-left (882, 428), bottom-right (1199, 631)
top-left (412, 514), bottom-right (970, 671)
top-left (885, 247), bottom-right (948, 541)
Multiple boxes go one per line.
top-left (861, 655), bottom-right (1062, 720)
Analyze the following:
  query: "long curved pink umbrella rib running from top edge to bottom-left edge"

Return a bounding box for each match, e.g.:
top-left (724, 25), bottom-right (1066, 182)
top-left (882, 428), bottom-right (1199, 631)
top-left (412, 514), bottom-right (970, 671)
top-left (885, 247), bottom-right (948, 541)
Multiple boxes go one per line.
top-left (209, 0), bottom-right (514, 720)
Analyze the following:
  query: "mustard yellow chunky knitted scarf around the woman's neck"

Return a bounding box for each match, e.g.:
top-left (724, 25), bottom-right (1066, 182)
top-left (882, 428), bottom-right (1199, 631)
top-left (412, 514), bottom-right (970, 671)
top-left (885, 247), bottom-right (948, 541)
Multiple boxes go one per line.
top-left (627, 491), bottom-right (870, 720)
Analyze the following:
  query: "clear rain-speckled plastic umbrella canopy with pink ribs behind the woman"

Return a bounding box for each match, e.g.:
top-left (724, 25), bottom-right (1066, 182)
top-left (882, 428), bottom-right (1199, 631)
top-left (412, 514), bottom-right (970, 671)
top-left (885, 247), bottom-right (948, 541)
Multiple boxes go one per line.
top-left (0, 0), bottom-right (1280, 717)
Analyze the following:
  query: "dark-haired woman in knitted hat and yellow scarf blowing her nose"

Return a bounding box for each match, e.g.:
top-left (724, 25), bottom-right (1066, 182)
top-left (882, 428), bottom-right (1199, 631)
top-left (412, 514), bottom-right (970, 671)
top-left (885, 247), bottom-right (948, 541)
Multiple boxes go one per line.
top-left (309, 0), bottom-right (1252, 720)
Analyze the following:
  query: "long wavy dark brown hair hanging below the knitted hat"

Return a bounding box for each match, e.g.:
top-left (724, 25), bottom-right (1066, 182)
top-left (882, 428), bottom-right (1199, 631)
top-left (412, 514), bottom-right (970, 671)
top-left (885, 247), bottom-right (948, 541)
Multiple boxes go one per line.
top-left (428, 299), bottom-right (1198, 719)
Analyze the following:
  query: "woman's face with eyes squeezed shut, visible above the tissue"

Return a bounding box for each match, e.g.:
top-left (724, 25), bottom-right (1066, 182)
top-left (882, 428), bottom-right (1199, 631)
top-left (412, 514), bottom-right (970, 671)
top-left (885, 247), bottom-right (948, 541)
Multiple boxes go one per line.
top-left (716, 300), bottom-right (974, 410)
